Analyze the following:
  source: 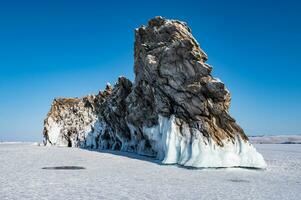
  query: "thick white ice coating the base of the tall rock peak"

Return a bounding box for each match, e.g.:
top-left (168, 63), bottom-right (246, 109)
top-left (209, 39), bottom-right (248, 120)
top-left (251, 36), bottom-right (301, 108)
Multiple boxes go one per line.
top-left (143, 116), bottom-right (266, 168)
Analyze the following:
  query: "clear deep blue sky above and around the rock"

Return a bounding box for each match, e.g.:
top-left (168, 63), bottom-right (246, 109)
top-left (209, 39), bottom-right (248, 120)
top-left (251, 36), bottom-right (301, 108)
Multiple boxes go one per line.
top-left (0, 0), bottom-right (301, 141)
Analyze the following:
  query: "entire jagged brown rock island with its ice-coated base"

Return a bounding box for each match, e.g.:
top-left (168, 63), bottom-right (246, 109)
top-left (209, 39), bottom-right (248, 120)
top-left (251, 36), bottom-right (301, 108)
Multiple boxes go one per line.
top-left (44, 17), bottom-right (266, 168)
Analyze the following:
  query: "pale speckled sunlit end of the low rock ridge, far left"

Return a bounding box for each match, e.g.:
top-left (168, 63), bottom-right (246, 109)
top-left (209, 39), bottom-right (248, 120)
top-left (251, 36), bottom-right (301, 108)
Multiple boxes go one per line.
top-left (44, 96), bottom-right (97, 147)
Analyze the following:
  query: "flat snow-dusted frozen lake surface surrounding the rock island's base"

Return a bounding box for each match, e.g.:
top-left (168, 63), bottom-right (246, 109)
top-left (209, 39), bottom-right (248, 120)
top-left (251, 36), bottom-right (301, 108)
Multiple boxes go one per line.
top-left (0, 143), bottom-right (301, 200)
